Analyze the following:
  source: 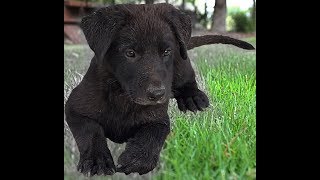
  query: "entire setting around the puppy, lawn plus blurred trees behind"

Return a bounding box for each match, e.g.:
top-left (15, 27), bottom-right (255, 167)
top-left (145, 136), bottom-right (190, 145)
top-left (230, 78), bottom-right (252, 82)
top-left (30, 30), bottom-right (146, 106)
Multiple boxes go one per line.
top-left (64, 0), bottom-right (256, 180)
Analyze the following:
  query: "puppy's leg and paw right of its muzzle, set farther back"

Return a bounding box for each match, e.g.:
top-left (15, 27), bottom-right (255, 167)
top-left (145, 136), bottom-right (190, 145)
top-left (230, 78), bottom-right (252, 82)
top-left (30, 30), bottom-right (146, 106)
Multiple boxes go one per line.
top-left (173, 58), bottom-right (209, 112)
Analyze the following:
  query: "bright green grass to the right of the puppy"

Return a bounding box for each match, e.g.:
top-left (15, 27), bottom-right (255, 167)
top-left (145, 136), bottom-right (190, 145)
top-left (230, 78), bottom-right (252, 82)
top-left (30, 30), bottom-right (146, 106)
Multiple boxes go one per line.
top-left (158, 46), bottom-right (256, 180)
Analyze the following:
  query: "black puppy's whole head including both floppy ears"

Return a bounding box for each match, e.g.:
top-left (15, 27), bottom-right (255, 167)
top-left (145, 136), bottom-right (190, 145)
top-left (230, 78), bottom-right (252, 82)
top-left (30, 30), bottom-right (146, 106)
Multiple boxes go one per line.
top-left (81, 4), bottom-right (191, 105)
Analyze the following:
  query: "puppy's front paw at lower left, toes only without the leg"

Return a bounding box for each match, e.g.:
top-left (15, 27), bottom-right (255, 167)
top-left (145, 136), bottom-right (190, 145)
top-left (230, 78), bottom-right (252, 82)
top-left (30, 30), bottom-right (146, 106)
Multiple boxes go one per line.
top-left (77, 154), bottom-right (115, 176)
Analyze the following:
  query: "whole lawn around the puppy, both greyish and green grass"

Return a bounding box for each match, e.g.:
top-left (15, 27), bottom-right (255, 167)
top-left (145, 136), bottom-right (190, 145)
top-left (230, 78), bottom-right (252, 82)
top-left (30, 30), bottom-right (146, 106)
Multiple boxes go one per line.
top-left (64, 38), bottom-right (256, 180)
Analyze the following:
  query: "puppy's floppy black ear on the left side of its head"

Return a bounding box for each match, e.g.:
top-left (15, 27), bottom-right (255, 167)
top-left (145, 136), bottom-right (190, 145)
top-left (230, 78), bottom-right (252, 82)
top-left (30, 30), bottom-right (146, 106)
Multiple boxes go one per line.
top-left (80, 6), bottom-right (125, 60)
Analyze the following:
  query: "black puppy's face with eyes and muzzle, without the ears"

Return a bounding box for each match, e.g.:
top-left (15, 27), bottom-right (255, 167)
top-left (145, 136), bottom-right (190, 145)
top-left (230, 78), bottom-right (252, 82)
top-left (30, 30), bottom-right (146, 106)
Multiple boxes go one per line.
top-left (106, 18), bottom-right (177, 105)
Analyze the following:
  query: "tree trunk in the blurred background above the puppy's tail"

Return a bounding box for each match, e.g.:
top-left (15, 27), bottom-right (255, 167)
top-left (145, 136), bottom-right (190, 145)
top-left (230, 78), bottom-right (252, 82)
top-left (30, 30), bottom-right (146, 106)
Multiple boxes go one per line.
top-left (212, 0), bottom-right (227, 33)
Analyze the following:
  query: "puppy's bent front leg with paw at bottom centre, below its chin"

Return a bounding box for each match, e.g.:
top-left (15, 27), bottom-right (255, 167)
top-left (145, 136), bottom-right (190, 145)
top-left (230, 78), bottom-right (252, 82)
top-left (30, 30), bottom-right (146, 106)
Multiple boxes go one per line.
top-left (117, 118), bottom-right (170, 175)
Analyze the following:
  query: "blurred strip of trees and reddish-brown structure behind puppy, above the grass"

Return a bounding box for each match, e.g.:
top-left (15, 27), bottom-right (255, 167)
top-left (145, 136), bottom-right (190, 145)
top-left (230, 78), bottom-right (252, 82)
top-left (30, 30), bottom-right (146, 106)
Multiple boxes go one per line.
top-left (64, 0), bottom-right (256, 44)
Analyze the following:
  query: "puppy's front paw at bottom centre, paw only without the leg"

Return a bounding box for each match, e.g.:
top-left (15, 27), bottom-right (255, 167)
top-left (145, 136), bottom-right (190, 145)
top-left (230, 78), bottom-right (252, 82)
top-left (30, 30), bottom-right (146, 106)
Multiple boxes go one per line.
top-left (117, 150), bottom-right (159, 175)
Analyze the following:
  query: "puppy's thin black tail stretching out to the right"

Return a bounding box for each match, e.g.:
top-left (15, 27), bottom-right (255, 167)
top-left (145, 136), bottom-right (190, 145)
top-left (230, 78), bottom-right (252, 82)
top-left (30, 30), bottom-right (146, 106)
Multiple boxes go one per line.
top-left (187, 35), bottom-right (255, 50)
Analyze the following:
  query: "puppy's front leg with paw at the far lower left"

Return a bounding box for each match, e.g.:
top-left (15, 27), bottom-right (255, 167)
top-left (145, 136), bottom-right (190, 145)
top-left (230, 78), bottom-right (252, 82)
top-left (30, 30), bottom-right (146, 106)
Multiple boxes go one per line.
top-left (66, 114), bottom-right (115, 176)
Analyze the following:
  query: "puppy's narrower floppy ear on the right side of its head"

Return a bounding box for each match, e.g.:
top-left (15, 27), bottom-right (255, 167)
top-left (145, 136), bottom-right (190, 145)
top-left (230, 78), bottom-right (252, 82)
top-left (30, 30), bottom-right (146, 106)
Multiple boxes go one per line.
top-left (165, 7), bottom-right (191, 59)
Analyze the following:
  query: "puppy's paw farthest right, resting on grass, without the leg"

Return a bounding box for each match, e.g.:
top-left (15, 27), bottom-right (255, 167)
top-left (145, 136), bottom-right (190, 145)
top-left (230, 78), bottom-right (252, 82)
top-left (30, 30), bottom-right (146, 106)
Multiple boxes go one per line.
top-left (176, 89), bottom-right (209, 112)
